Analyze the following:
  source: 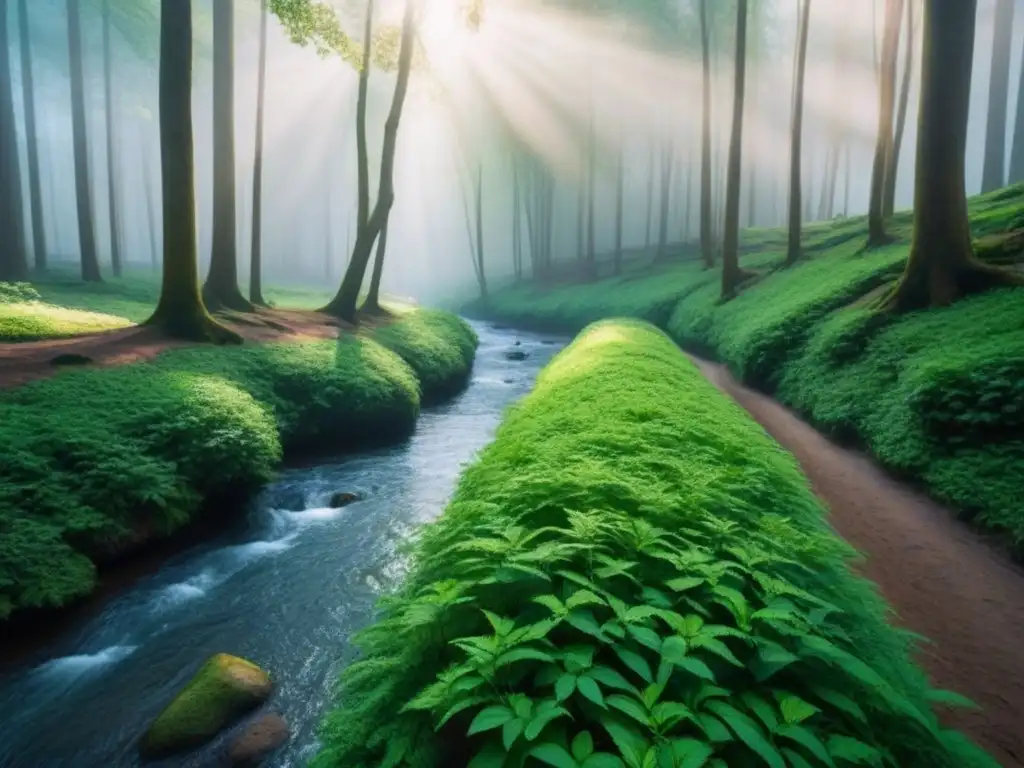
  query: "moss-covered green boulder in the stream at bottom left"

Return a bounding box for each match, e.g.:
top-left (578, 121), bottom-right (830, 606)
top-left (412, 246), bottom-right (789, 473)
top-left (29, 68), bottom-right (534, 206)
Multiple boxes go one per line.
top-left (139, 653), bottom-right (273, 759)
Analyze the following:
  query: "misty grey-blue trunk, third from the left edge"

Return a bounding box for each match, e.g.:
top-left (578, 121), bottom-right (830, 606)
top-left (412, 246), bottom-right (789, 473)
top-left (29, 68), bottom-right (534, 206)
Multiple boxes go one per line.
top-left (68, 0), bottom-right (102, 283)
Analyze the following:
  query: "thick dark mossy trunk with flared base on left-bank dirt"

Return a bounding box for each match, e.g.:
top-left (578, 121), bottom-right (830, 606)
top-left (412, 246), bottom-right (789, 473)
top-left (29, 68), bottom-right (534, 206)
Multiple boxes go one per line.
top-left (146, 0), bottom-right (242, 342)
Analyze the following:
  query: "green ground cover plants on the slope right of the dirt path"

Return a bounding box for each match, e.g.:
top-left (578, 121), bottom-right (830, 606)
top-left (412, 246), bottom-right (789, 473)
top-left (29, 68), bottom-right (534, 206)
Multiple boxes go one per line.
top-left (479, 184), bottom-right (1024, 554)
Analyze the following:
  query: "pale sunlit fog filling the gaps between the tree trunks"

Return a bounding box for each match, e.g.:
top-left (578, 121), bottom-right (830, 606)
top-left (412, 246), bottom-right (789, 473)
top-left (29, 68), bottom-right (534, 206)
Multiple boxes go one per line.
top-left (7, 0), bottom-right (1024, 302)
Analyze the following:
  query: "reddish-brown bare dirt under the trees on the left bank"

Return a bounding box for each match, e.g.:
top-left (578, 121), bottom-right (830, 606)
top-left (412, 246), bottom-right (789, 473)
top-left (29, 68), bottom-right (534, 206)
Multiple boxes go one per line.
top-left (0, 309), bottom-right (356, 389)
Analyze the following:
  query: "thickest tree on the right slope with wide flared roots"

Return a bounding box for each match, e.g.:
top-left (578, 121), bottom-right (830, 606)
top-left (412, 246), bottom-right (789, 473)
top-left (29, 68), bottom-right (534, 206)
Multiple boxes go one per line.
top-left (883, 0), bottom-right (1024, 311)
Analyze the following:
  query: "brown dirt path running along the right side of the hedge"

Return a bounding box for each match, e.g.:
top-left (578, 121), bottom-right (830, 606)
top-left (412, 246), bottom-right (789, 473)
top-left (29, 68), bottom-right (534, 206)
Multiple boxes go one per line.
top-left (693, 358), bottom-right (1024, 768)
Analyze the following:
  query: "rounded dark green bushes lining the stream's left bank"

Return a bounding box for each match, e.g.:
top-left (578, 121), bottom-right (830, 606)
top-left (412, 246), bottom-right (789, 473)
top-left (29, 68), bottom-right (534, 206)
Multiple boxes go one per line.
top-left (0, 310), bottom-right (476, 618)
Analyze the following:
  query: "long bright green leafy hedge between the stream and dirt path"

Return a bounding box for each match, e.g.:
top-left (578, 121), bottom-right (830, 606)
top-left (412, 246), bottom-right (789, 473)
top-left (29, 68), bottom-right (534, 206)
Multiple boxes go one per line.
top-left (313, 321), bottom-right (994, 768)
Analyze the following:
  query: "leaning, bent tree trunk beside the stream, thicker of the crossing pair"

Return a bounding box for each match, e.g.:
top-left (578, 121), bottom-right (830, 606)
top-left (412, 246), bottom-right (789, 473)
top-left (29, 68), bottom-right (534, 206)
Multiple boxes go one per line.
top-left (324, 0), bottom-right (415, 323)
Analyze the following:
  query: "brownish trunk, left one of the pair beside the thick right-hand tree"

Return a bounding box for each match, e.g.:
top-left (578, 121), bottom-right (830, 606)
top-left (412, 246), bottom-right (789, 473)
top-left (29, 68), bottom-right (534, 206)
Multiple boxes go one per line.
top-left (867, 0), bottom-right (903, 248)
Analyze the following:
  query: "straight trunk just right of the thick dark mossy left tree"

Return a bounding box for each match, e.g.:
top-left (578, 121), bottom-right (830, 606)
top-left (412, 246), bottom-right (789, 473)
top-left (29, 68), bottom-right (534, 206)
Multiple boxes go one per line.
top-left (203, 0), bottom-right (253, 311)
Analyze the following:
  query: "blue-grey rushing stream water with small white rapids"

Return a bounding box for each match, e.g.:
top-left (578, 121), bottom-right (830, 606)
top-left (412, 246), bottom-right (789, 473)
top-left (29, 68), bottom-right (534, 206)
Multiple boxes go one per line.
top-left (0, 325), bottom-right (562, 768)
